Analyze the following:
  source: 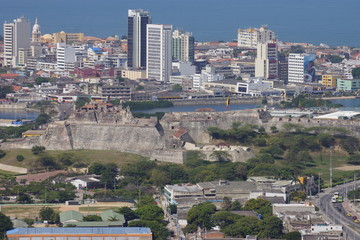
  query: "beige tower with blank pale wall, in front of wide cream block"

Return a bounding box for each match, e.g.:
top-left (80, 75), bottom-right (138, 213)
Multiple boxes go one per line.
top-left (255, 42), bottom-right (278, 79)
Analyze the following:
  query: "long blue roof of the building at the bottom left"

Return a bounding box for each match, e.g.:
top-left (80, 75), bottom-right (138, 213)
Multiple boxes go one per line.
top-left (6, 227), bottom-right (151, 235)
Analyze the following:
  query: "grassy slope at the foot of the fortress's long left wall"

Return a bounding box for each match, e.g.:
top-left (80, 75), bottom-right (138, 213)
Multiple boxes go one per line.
top-left (0, 149), bottom-right (145, 174)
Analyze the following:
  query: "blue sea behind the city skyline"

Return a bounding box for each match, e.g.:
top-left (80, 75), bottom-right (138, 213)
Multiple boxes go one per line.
top-left (0, 0), bottom-right (360, 47)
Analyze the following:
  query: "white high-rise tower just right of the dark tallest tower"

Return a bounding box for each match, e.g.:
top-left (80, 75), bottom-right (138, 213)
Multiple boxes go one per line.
top-left (146, 24), bottom-right (172, 82)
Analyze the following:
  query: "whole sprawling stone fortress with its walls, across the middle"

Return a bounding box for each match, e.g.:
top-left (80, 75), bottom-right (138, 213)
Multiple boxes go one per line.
top-left (1, 107), bottom-right (360, 163)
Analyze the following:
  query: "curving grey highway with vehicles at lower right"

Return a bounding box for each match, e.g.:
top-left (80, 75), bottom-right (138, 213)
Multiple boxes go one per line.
top-left (317, 181), bottom-right (360, 240)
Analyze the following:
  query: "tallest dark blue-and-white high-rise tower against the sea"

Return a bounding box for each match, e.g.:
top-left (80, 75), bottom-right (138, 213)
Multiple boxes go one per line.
top-left (128, 9), bottom-right (151, 68)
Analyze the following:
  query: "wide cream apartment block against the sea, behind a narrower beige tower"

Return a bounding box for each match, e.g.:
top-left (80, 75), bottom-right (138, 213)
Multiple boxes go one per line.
top-left (238, 26), bottom-right (276, 48)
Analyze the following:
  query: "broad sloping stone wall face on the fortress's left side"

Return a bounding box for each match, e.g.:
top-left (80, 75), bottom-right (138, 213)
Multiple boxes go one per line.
top-left (39, 123), bottom-right (164, 157)
